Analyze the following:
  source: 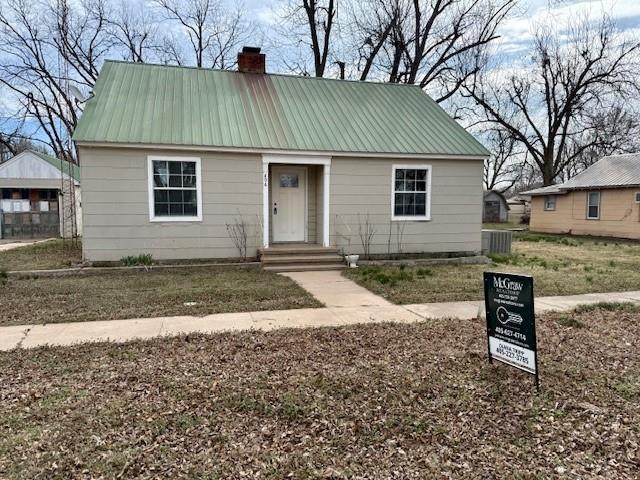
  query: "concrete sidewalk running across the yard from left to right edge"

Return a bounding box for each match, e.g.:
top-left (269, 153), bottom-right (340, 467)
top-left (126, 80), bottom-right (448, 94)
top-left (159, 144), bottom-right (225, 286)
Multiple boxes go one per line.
top-left (0, 285), bottom-right (640, 350)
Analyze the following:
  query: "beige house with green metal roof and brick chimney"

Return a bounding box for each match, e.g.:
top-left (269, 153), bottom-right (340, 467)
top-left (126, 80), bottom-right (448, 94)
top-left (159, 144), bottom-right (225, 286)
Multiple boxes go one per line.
top-left (74, 48), bottom-right (488, 261)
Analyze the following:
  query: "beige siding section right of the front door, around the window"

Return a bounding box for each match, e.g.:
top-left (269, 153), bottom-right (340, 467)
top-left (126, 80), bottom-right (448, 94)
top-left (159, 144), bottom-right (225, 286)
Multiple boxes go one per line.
top-left (330, 157), bottom-right (482, 255)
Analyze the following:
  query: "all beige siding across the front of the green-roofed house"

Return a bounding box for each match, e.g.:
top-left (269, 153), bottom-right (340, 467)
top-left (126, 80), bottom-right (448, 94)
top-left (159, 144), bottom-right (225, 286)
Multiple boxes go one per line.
top-left (80, 147), bottom-right (482, 261)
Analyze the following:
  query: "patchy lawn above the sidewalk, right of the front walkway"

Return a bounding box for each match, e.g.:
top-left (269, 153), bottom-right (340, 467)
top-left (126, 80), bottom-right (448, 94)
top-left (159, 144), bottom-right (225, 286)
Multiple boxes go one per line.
top-left (344, 233), bottom-right (640, 304)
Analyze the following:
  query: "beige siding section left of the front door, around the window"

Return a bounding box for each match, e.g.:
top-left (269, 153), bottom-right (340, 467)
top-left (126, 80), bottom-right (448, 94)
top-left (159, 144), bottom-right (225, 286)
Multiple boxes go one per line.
top-left (80, 147), bottom-right (262, 261)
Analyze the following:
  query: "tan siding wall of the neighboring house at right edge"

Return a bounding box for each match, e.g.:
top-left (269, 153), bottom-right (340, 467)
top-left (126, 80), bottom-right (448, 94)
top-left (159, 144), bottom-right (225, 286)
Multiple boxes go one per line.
top-left (529, 188), bottom-right (640, 239)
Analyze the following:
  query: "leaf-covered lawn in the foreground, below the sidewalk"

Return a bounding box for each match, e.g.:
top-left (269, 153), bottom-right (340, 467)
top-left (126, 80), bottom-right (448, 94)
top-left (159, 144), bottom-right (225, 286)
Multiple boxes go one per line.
top-left (0, 310), bottom-right (640, 479)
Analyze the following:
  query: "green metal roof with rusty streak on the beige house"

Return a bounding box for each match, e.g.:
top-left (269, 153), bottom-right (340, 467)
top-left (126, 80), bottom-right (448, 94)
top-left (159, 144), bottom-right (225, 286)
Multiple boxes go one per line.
top-left (73, 61), bottom-right (489, 156)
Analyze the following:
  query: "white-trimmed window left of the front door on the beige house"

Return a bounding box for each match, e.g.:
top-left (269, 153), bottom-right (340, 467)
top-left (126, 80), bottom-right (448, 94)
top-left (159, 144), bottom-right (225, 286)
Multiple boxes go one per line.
top-left (148, 157), bottom-right (202, 222)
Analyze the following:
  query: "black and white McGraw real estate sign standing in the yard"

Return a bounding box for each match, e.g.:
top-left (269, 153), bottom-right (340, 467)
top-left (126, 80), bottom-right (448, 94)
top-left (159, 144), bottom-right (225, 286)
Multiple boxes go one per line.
top-left (484, 272), bottom-right (540, 389)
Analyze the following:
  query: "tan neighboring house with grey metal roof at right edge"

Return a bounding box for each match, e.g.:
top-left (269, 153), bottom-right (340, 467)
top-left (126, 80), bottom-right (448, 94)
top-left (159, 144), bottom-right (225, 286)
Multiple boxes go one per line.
top-left (524, 153), bottom-right (640, 239)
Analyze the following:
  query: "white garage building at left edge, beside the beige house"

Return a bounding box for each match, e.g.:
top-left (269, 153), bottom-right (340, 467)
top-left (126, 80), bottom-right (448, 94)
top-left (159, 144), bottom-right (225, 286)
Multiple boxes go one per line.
top-left (0, 150), bottom-right (82, 238)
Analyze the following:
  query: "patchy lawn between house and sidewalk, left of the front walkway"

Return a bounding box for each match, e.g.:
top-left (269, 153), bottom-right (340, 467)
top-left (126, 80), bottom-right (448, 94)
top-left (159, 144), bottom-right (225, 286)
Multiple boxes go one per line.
top-left (0, 268), bottom-right (321, 325)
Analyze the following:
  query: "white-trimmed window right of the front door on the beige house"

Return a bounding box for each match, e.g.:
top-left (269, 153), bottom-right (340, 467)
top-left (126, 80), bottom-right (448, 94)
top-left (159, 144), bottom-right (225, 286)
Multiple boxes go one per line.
top-left (391, 165), bottom-right (431, 220)
